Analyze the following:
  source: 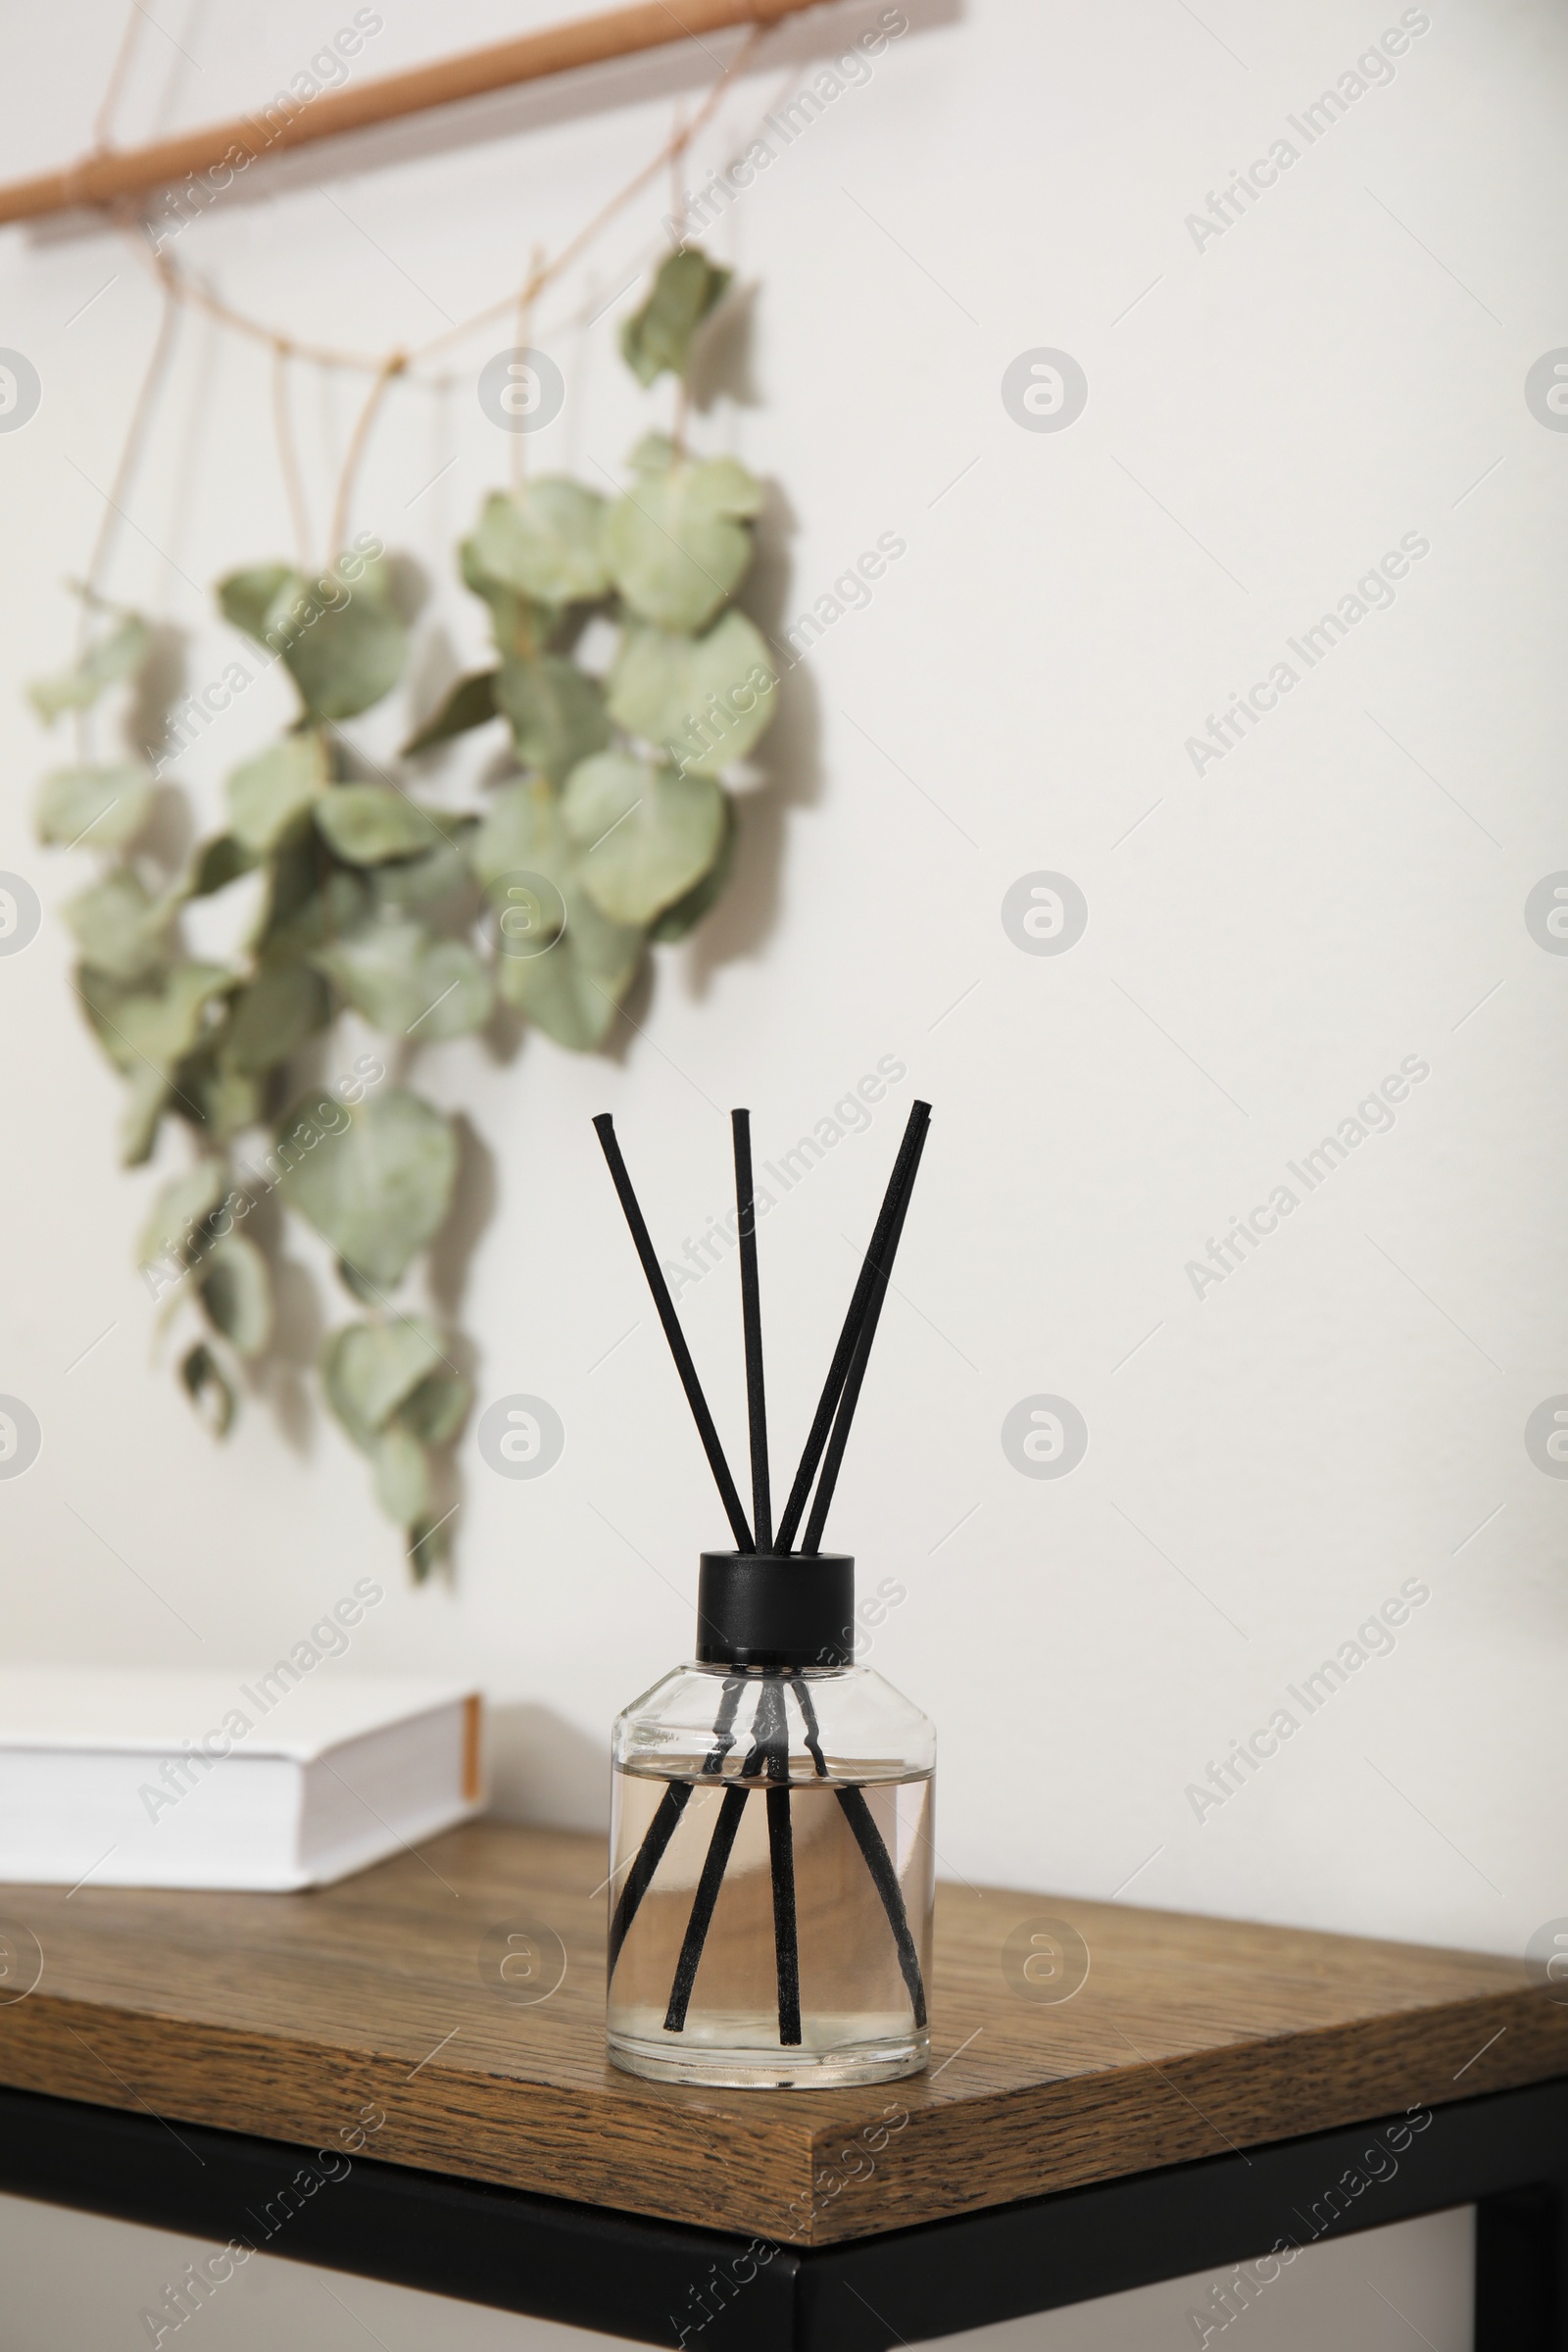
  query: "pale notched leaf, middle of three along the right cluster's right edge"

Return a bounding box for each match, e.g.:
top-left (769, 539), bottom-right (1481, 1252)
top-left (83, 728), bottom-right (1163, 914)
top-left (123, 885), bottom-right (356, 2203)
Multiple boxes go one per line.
top-left (609, 612), bottom-right (778, 776)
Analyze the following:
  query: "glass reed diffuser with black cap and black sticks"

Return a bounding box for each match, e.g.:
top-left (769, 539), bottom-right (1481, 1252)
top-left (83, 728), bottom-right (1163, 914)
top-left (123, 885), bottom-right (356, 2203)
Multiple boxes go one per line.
top-left (592, 1103), bottom-right (936, 2088)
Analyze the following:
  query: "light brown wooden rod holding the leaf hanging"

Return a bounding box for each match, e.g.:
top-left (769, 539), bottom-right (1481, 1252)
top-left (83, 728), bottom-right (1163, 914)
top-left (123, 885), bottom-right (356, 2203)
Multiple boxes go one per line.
top-left (0, 0), bottom-right (820, 221)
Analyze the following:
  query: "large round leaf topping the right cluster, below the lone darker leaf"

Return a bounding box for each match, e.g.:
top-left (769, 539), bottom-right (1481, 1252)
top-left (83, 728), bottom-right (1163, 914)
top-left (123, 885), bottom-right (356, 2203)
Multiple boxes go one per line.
top-left (604, 442), bottom-right (764, 630)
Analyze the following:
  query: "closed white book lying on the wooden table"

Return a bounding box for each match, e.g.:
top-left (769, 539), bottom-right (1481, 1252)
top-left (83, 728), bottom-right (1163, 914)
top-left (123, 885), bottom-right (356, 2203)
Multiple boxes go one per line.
top-left (0, 1660), bottom-right (482, 1888)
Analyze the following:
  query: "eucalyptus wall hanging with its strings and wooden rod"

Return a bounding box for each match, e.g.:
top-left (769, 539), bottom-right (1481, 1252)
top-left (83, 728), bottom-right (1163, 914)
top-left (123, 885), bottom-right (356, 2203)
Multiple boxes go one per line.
top-left (18, 0), bottom-right (817, 1578)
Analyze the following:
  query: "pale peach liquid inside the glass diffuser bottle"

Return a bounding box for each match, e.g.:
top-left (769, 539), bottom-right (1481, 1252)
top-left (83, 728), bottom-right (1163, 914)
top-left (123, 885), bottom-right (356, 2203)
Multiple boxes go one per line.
top-left (607, 1759), bottom-right (933, 2086)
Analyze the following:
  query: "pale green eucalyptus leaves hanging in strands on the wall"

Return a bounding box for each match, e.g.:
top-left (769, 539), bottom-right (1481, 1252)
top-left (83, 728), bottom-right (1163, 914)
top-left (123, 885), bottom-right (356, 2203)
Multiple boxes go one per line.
top-left (30, 247), bottom-right (778, 1576)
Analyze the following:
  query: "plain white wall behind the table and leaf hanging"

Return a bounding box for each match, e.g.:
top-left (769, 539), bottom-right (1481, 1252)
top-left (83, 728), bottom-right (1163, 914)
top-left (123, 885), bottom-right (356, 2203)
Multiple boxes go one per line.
top-left (0, 0), bottom-right (1568, 2340)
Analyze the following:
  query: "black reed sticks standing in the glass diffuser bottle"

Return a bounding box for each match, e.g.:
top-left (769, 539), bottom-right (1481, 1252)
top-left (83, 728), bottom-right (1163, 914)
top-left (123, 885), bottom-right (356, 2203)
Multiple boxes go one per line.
top-left (592, 1101), bottom-right (931, 2046)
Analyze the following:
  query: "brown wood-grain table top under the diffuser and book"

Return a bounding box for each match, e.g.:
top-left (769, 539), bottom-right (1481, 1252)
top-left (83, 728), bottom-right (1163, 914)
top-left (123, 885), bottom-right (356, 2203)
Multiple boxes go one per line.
top-left (0, 1821), bottom-right (1568, 2246)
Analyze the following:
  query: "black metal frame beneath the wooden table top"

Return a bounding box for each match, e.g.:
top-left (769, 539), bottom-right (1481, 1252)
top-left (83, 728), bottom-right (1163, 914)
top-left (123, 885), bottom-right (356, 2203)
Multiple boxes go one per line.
top-left (0, 2077), bottom-right (1568, 2352)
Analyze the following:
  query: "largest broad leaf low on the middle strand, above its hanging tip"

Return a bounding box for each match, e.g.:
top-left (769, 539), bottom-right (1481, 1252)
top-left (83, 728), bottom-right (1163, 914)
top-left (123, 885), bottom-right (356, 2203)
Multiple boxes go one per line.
top-left (277, 1087), bottom-right (459, 1289)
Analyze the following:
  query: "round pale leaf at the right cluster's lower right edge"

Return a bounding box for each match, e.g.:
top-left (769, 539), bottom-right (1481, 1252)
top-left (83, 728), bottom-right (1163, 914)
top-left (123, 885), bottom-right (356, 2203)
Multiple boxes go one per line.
top-left (562, 751), bottom-right (724, 924)
